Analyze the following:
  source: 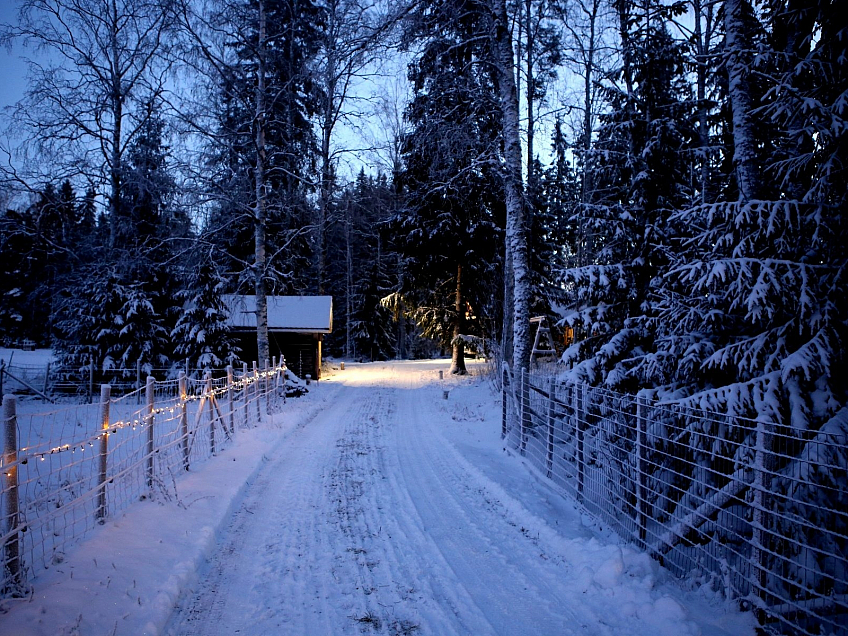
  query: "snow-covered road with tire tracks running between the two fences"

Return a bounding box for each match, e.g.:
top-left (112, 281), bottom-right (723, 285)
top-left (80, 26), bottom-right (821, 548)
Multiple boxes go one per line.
top-left (166, 363), bottom-right (746, 636)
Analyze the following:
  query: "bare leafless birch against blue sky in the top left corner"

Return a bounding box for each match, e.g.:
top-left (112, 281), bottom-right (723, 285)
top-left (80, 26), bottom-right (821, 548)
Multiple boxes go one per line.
top-left (0, 0), bottom-right (172, 251)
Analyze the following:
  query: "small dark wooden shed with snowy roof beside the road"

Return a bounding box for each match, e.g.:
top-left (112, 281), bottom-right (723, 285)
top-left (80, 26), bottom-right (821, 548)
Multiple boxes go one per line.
top-left (223, 294), bottom-right (333, 379)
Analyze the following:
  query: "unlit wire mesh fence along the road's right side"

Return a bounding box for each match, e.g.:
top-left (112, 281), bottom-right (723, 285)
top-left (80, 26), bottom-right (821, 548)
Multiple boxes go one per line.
top-left (502, 369), bottom-right (848, 636)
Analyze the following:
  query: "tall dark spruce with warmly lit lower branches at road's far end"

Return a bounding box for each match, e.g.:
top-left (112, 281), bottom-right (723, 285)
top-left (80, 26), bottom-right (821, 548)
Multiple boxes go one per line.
top-left (392, 0), bottom-right (502, 374)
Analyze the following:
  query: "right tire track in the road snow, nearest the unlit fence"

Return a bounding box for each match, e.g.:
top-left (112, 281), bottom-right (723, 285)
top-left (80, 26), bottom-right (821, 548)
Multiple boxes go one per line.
top-left (388, 370), bottom-right (586, 634)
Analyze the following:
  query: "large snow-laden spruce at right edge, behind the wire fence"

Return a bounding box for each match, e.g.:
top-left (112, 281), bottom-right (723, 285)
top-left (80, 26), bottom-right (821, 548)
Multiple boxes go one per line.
top-left (662, 0), bottom-right (848, 430)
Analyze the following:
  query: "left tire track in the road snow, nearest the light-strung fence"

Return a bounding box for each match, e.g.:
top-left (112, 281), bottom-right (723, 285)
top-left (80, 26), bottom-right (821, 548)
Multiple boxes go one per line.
top-left (168, 388), bottom-right (353, 636)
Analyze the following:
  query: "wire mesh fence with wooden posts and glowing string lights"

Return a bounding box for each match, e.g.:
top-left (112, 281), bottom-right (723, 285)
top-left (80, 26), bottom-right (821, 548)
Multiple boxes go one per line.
top-left (0, 363), bottom-right (286, 596)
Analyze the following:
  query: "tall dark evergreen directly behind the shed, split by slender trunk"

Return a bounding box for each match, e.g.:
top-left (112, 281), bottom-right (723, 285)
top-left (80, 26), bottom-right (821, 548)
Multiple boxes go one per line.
top-left (206, 0), bottom-right (322, 293)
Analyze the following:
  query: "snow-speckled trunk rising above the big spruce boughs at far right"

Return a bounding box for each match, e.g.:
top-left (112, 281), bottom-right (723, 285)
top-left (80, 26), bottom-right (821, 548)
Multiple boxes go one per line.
top-left (724, 0), bottom-right (760, 201)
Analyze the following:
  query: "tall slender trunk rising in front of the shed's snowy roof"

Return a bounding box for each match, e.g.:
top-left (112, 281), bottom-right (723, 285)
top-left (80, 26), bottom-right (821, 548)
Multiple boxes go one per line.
top-left (253, 0), bottom-right (270, 367)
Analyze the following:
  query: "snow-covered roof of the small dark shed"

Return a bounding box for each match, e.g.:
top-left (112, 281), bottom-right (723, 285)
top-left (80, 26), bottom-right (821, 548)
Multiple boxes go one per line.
top-left (223, 294), bottom-right (333, 333)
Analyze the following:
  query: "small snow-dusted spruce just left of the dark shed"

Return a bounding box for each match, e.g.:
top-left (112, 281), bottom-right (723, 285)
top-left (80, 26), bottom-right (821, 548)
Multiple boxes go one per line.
top-left (171, 258), bottom-right (239, 369)
